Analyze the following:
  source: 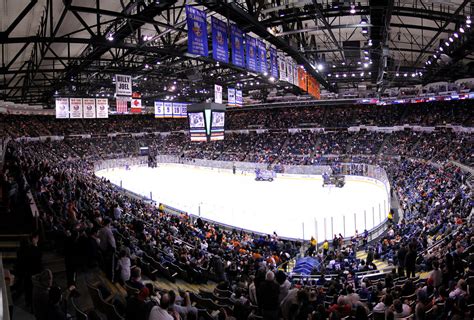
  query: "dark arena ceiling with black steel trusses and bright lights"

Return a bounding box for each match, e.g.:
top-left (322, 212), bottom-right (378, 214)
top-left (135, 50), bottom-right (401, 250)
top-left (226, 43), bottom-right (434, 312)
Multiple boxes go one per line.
top-left (0, 0), bottom-right (474, 103)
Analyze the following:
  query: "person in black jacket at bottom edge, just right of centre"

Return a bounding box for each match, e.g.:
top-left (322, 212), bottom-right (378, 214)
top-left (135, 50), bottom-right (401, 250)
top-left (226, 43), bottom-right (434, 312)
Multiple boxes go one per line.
top-left (257, 271), bottom-right (280, 320)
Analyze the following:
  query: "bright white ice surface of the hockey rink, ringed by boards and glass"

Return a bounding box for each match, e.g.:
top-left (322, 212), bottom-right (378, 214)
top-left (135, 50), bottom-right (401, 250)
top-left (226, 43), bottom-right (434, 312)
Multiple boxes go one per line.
top-left (96, 164), bottom-right (389, 241)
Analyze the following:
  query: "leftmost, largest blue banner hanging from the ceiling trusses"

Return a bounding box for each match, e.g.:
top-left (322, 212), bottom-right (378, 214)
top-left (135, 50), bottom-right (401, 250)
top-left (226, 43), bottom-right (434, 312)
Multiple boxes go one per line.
top-left (186, 5), bottom-right (209, 57)
